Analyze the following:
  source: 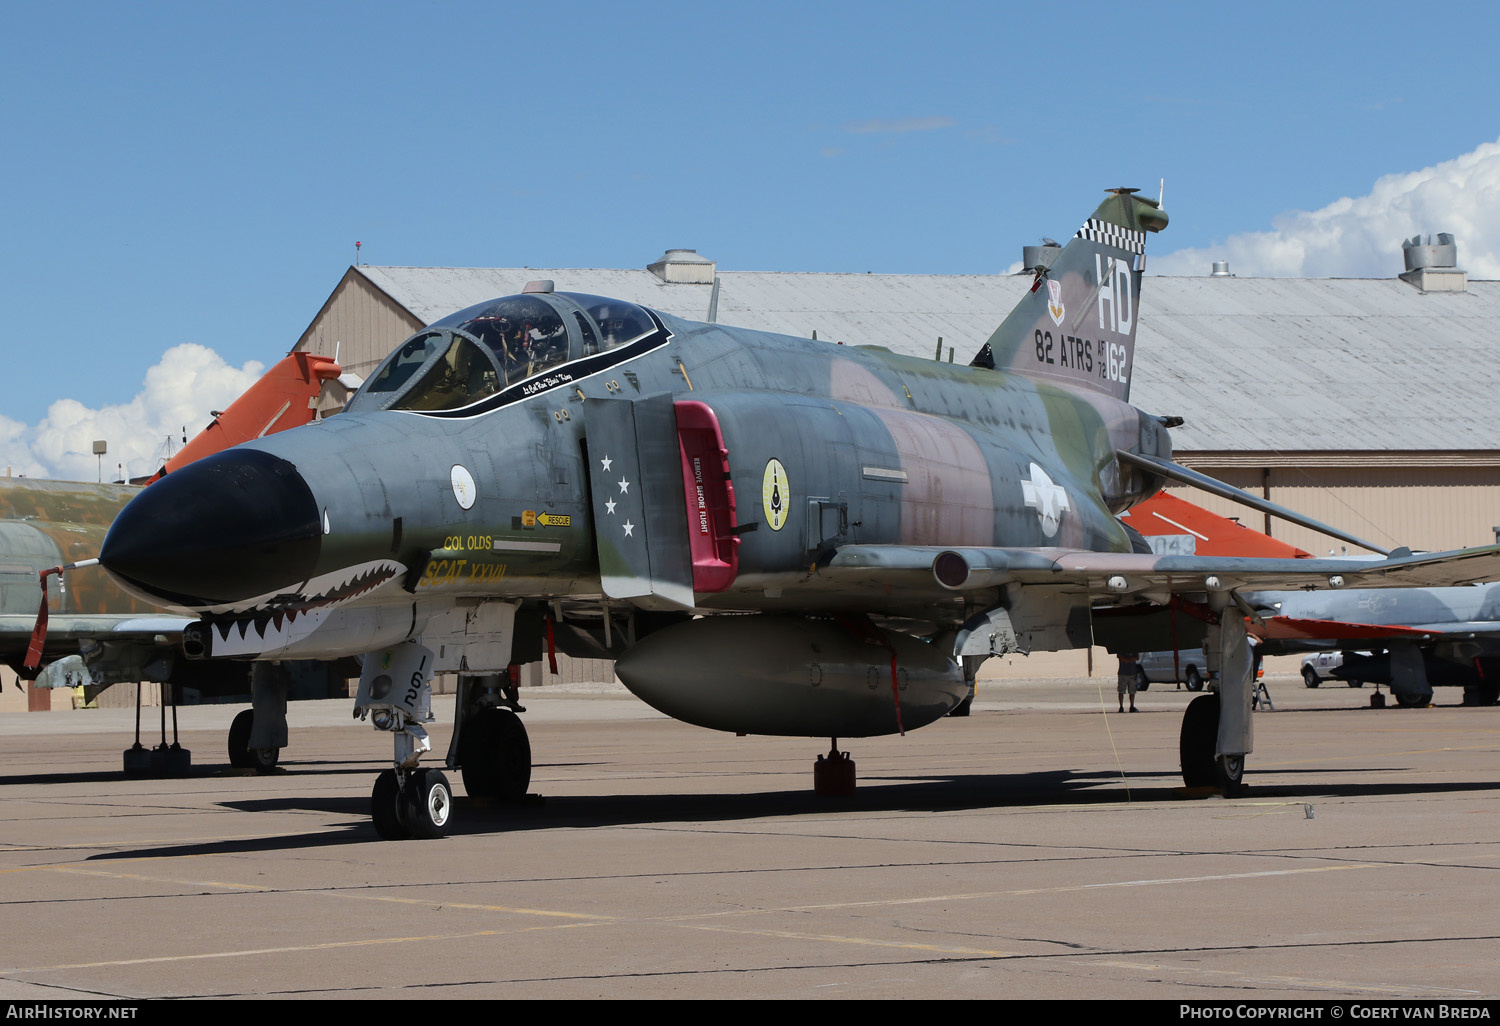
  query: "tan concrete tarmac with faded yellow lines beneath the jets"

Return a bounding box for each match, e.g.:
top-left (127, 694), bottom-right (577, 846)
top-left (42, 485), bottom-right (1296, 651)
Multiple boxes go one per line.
top-left (0, 678), bottom-right (1500, 1002)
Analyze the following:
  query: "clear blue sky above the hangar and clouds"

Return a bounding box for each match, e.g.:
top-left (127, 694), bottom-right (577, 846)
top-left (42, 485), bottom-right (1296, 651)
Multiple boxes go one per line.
top-left (0, 0), bottom-right (1500, 473)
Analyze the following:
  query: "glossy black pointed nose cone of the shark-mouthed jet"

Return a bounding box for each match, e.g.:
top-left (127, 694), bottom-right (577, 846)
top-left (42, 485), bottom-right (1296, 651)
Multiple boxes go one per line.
top-left (99, 449), bottom-right (323, 609)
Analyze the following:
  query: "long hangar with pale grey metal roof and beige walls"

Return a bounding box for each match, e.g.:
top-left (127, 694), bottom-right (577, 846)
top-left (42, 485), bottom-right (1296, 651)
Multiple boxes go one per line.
top-left (296, 243), bottom-right (1500, 681)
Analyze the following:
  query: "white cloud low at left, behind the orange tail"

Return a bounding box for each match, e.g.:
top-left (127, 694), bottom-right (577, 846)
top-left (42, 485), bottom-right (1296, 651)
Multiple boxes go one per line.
top-left (0, 342), bottom-right (266, 482)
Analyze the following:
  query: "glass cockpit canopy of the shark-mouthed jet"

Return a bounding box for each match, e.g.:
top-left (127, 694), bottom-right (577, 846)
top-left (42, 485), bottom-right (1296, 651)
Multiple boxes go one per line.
top-left (347, 293), bottom-right (656, 411)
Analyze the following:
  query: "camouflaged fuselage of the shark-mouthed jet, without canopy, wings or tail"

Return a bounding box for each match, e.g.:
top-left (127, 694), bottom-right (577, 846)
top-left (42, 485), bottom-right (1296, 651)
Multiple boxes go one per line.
top-left (105, 294), bottom-right (1170, 651)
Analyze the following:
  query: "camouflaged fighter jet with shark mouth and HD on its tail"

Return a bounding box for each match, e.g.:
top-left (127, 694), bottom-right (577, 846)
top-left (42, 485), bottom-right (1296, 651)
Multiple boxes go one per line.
top-left (101, 189), bottom-right (1500, 839)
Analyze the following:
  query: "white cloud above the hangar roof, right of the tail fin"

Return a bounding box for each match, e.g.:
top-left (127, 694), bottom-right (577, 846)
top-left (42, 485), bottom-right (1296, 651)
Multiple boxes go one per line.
top-left (1149, 141), bottom-right (1500, 279)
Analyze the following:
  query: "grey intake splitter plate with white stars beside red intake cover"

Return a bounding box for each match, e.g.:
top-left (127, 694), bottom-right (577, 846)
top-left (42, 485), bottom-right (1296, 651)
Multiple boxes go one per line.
top-left (584, 395), bottom-right (695, 609)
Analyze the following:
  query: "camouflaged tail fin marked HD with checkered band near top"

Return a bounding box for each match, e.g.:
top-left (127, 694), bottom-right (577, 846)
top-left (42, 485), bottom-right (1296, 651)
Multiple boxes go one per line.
top-left (971, 189), bottom-right (1167, 402)
